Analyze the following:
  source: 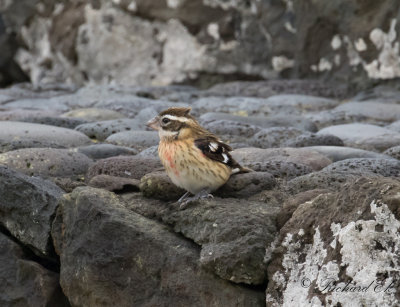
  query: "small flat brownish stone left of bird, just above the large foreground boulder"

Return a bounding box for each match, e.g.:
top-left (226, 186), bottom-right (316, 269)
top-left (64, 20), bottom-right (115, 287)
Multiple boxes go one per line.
top-left (88, 175), bottom-right (140, 194)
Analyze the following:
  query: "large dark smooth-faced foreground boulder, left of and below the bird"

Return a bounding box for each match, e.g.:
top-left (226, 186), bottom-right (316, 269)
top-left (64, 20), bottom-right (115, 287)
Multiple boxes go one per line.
top-left (52, 188), bottom-right (266, 306)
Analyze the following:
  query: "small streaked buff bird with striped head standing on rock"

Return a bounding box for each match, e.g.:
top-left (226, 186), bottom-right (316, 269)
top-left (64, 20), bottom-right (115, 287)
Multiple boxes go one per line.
top-left (147, 107), bottom-right (251, 208)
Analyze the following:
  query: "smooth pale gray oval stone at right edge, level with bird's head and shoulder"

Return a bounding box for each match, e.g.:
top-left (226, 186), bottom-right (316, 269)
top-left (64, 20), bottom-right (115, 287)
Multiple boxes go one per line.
top-left (317, 123), bottom-right (400, 152)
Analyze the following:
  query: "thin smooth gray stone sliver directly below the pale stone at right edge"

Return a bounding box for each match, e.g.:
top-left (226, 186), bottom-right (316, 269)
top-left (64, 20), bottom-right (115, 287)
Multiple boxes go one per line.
top-left (306, 146), bottom-right (389, 162)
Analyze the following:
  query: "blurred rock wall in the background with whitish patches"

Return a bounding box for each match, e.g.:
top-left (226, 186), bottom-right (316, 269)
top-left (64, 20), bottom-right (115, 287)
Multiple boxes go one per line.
top-left (0, 0), bottom-right (400, 89)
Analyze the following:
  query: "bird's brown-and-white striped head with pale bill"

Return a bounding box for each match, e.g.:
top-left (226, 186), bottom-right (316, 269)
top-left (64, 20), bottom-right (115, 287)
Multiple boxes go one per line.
top-left (147, 107), bottom-right (202, 141)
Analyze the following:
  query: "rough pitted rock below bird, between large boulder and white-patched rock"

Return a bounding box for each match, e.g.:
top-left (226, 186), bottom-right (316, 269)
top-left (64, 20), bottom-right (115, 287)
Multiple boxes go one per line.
top-left (162, 198), bottom-right (278, 285)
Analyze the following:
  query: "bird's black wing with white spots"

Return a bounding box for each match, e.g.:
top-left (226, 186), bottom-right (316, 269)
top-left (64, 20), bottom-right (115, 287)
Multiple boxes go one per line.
top-left (194, 137), bottom-right (241, 171)
